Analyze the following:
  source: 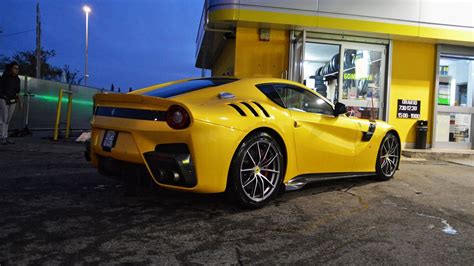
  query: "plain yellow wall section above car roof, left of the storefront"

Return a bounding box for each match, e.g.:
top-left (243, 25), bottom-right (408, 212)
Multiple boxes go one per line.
top-left (235, 27), bottom-right (290, 78)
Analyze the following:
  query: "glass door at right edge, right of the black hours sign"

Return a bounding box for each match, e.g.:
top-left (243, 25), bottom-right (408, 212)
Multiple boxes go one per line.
top-left (434, 54), bottom-right (474, 149)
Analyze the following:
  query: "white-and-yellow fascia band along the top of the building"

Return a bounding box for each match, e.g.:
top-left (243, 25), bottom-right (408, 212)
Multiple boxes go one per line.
top-left (206, 0), bottom-right (474, 42)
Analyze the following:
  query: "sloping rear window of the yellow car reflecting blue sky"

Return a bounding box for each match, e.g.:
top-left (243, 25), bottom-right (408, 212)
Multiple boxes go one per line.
top-left (143, 78), bottom-right (237, 98)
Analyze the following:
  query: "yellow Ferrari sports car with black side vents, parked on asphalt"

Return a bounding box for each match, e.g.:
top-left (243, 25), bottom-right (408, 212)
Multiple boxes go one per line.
top-left (89, 78), bottom-right (400, 207)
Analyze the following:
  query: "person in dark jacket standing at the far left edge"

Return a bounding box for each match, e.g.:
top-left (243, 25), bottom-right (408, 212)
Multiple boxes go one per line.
top-left (0, 62), bottom-right (20, 145)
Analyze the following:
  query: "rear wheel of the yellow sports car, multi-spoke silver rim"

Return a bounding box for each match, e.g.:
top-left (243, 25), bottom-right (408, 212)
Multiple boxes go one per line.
top-left (226, 132), bottom-right (285, 208)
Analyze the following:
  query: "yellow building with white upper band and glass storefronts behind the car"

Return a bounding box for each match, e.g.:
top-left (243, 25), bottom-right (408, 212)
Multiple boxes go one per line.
top-left (196, 0), bottom-right (474, 149)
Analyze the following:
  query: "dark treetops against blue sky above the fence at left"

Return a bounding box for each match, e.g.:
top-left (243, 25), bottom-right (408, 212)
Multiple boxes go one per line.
top-left (0, 48), bottom-right (62, 81)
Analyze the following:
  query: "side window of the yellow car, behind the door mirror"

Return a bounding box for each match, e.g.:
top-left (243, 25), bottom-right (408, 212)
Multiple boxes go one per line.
top-left (274, 84), bottom-right (334, 115)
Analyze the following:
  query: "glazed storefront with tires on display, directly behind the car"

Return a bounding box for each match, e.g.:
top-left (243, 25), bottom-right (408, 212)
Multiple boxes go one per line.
top-left (292, 34), bottom-right (386, 119)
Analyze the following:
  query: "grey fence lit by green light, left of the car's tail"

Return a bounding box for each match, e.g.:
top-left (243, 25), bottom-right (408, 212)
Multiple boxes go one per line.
top-left (10, 76), bottom-right (100, 130)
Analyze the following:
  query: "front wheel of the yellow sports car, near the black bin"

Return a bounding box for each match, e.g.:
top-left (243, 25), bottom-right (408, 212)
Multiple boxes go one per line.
top-left (375, 132), bottom-right (401, 181)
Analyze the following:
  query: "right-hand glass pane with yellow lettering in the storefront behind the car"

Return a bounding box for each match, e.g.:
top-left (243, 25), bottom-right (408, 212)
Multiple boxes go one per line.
top-left (339, 43), bottom-right (386, 119)
